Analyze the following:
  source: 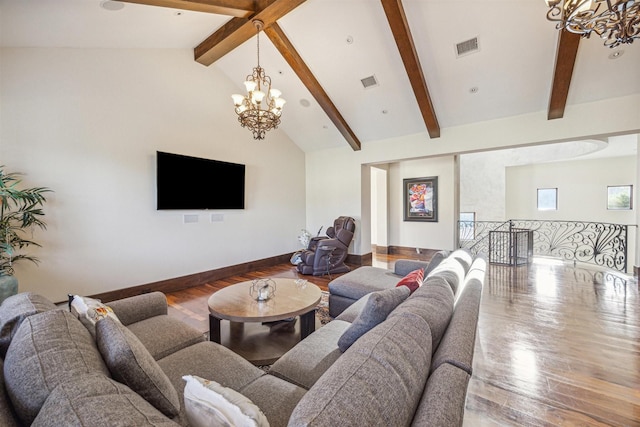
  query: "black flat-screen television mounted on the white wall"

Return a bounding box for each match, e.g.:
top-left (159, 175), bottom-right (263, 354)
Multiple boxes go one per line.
top-left (156, 151), bottom-right (245, 210)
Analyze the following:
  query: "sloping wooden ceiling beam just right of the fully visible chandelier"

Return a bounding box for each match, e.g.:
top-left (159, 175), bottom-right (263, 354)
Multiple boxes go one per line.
top-left (264, 23), bottom-right (361, 151)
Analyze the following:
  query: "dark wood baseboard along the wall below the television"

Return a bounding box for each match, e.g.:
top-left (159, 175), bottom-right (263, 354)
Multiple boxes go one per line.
top-left (91, 253), bottom-right (293, 302)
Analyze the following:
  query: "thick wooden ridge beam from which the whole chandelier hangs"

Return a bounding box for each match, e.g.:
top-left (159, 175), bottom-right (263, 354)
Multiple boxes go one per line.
top-left (194, 0), bottom-right (305, 65)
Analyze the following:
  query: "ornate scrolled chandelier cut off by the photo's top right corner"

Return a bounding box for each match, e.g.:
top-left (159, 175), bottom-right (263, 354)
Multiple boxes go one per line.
top-left (545, 0), bottom-right (640, 48)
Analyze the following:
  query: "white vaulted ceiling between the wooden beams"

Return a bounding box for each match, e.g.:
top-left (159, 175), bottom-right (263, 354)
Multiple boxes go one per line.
top-left (0, 0), bottom-right (640, 151)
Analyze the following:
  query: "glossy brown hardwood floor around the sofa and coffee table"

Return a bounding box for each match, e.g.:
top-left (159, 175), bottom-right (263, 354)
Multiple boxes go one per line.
top-left (162, 255), bottom-right (640, 427)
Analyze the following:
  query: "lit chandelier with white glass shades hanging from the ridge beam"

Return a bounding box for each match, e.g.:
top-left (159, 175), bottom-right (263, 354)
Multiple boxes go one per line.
top-left (231, 19), bottom-right (286, 139)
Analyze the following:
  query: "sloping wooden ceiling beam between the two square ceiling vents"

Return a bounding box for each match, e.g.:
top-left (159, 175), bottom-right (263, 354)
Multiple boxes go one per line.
top-left (381, 0), bottom-right (440, 138)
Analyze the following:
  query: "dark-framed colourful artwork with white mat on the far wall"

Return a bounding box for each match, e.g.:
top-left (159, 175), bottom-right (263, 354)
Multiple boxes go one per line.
top-left (402, 176), bottom-right (438, 222)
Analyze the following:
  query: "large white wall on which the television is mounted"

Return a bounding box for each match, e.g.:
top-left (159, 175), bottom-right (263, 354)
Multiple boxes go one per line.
top-left (0, 49), bottom-right (305, 301)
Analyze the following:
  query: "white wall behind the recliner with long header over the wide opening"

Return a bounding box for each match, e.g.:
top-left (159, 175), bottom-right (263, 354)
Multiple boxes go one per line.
top-left (306, 95), bottom-right (640, 254)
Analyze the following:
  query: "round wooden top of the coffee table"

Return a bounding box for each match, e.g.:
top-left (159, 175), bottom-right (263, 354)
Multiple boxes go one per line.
top-left (208, 277), bottom-right (322, 322)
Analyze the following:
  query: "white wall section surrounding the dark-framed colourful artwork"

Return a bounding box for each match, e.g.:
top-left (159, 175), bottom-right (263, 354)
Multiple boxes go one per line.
top-left (389, 156), bottom-right (457, 249)
